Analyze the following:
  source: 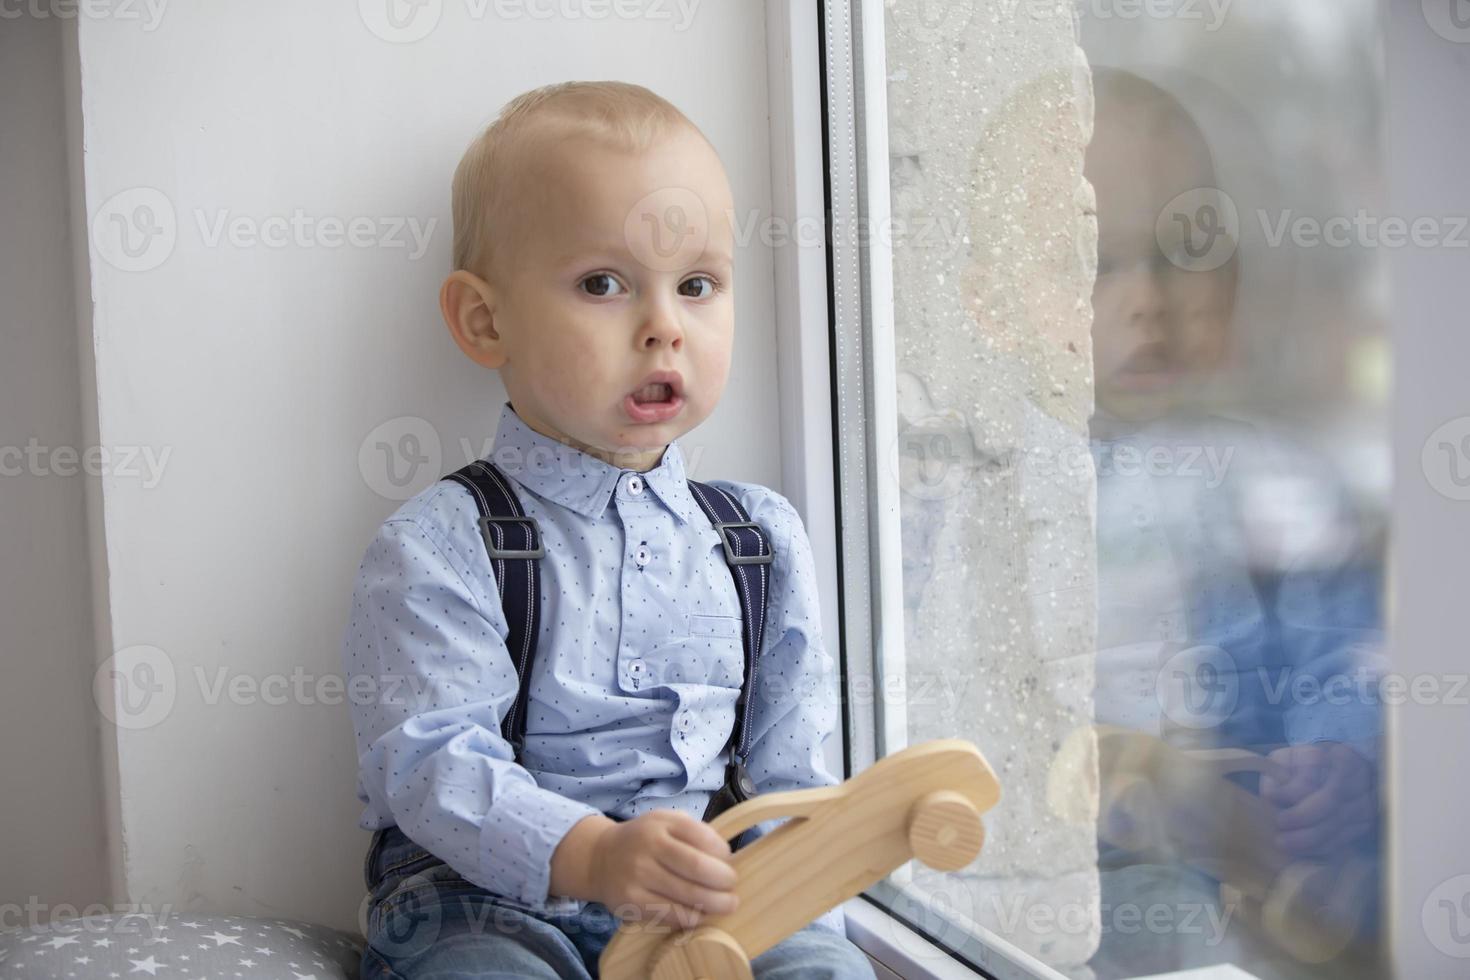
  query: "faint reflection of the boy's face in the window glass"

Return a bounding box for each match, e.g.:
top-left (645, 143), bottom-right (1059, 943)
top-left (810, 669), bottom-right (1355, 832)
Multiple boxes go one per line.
top-left (1085, 106), bottom-right (1235, 422)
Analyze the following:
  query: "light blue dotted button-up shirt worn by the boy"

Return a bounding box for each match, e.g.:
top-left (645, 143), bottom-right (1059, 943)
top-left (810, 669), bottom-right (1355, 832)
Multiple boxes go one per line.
top-left (343, 403), bottom-right (842, 929)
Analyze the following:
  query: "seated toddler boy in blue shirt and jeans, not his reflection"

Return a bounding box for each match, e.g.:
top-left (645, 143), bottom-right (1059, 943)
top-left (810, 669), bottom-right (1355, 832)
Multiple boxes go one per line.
top-left (343, 82), bottom-right (873, 977)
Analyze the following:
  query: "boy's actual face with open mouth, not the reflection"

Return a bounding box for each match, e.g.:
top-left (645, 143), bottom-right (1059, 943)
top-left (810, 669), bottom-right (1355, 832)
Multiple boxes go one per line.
top-left (492, 132), bottom-right (735, 469)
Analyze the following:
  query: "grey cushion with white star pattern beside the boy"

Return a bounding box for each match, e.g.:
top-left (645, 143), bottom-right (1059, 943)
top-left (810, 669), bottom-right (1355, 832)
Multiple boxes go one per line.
top-left (0, 912), bottom-right (363, 980)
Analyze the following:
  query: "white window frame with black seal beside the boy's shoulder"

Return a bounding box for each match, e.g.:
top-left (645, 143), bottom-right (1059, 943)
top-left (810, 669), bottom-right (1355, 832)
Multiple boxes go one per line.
top-left (766, 0), bottom-right (1063, 980)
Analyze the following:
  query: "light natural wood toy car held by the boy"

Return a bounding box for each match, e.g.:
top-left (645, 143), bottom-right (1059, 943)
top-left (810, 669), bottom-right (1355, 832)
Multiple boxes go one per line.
top-left (598, 739), bottom-right (1001, 980)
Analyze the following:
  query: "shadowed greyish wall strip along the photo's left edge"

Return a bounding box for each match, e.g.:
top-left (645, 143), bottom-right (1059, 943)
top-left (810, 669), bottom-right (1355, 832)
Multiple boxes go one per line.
top-left (0, 19), bottom-right (107, 929)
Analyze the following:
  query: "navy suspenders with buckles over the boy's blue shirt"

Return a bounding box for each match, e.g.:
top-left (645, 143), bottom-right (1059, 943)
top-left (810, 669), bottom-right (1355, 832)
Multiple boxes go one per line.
top-left (444, 460), bottom-right (773, 848)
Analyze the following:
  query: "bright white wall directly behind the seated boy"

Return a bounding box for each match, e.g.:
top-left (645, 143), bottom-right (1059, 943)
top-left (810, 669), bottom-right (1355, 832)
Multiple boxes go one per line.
top-left (69, 0), bottom-right (781, 929)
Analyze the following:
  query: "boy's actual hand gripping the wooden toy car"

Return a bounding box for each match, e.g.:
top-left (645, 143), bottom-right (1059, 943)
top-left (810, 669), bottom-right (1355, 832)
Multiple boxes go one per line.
top-left (591, 810), bottom-right (738, 929)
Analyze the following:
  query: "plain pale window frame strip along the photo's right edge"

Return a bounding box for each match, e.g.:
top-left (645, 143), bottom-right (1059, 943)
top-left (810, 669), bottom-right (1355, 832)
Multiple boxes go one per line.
top-left (1380, 0), bottom-right (1470, 980)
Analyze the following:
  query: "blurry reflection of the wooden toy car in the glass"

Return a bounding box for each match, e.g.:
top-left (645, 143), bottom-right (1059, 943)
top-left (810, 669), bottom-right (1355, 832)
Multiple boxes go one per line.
top-left (1081, 726), bottom-right (1373, 962)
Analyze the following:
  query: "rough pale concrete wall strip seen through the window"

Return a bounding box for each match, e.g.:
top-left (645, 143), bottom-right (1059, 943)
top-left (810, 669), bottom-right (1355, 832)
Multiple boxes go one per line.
top-left (885, 0), bottom-right (1100, 976)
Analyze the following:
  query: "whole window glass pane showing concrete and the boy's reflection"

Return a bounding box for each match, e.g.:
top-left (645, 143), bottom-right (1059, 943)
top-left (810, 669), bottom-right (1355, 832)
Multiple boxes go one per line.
top-left (864, 0), bottom-right (1387, 979)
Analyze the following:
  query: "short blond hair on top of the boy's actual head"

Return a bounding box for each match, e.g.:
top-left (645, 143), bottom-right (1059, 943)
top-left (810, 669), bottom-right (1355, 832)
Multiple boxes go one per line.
top-left (453, 81), bottom-right (709, 276)
